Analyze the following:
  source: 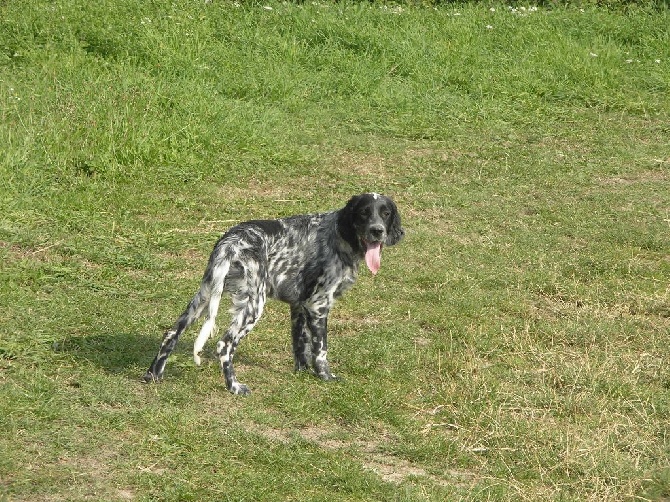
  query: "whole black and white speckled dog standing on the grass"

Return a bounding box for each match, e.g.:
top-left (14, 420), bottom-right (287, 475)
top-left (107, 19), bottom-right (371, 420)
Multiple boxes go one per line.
top-left (144, 193), bottom-right (405, 394)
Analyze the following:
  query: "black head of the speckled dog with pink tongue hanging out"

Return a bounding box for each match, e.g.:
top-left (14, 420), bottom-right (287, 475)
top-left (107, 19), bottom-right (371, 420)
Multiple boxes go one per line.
top-left (337, 193), bottom-right (405, 274)
